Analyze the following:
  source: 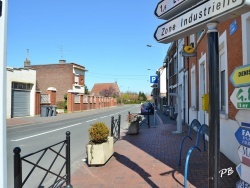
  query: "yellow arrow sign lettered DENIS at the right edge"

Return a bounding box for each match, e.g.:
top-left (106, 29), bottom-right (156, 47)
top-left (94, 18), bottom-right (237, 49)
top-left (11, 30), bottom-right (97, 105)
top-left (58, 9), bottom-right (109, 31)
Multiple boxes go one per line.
top-left (230, 64), bottom-right (250, 87)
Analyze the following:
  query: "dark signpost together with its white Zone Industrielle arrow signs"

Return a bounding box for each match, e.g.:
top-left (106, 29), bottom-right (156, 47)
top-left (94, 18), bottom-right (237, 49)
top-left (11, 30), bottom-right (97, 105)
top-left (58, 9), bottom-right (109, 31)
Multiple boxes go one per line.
top-left (154, 0), bottom-right (250, 188)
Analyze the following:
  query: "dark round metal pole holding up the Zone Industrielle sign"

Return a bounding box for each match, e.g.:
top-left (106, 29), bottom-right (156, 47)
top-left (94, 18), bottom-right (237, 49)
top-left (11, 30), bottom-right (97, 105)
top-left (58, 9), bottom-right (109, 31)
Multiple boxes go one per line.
top-left (207, 23), bottom-right (220, 188)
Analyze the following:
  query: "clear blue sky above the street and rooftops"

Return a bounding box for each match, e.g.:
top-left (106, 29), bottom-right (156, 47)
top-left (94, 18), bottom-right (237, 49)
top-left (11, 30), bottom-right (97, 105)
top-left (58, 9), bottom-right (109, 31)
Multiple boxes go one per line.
top-left (7, 0), bottom-right (169, 94)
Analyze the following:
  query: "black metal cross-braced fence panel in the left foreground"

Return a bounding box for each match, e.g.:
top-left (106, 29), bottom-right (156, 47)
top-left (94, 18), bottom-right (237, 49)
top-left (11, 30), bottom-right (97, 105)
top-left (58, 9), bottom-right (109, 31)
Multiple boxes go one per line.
top-left (13, 131), bottom-right (73, 188)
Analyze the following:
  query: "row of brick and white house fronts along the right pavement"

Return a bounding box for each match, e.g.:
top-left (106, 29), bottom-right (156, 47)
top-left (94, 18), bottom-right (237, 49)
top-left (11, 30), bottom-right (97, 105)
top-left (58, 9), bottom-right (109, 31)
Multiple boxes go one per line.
top-left (166, 12), bottom-right (250, 164)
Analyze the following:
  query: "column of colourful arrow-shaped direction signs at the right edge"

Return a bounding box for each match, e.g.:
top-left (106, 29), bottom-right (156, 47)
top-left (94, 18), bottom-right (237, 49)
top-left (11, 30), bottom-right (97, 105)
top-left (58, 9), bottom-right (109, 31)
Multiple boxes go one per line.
top-left (230, 65), bottom-right (250, 188)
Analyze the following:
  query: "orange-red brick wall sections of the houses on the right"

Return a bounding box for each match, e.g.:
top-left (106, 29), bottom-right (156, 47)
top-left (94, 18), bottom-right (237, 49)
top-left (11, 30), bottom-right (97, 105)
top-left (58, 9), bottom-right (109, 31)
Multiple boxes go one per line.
top-left (188, 16), bottom-right (243, 119)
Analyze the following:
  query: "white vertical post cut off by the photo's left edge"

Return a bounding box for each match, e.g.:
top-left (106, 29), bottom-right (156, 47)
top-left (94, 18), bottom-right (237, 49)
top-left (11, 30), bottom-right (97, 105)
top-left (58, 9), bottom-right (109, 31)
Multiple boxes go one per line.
top-left (0, 0), bottom-right (8, 187)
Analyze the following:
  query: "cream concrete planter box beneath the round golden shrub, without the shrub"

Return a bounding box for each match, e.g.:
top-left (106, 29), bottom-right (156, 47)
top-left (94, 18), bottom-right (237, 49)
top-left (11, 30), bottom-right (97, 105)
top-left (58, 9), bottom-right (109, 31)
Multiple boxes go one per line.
top-left (86, 137), bottom-right (114, 165)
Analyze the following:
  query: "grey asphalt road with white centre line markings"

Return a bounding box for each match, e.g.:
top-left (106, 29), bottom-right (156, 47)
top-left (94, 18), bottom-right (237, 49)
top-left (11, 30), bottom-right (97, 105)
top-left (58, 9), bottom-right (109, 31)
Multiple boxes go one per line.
top-left (7, 105), bottom-right (140, 188)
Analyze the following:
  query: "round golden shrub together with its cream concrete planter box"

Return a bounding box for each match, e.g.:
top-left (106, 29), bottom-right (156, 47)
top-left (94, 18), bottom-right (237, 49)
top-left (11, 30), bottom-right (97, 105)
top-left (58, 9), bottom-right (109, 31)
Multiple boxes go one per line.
top-left (86, 122), bottom-right (114, 165)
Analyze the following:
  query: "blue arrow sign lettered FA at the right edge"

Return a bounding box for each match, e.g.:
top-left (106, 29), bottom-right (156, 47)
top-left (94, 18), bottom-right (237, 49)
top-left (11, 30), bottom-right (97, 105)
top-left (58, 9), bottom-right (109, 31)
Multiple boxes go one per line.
top-left (235, 127), bottom-right (250, 147)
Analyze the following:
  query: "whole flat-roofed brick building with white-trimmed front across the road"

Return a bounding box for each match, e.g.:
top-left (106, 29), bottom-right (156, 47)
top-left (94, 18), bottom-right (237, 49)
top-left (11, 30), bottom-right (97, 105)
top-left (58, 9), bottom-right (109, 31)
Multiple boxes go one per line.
top-left (24, 60), bottom-right (86, 102)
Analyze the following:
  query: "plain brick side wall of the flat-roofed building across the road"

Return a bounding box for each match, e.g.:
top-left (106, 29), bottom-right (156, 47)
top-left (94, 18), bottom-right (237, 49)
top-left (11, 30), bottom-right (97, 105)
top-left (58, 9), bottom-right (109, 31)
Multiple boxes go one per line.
top-left (29, 64), bottom-right (74, 101)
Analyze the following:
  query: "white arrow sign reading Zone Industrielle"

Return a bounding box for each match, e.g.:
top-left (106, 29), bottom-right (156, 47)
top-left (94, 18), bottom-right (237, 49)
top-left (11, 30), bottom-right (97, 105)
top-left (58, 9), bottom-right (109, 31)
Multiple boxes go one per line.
top-left (154, 0), bottom-right (250, 43)
